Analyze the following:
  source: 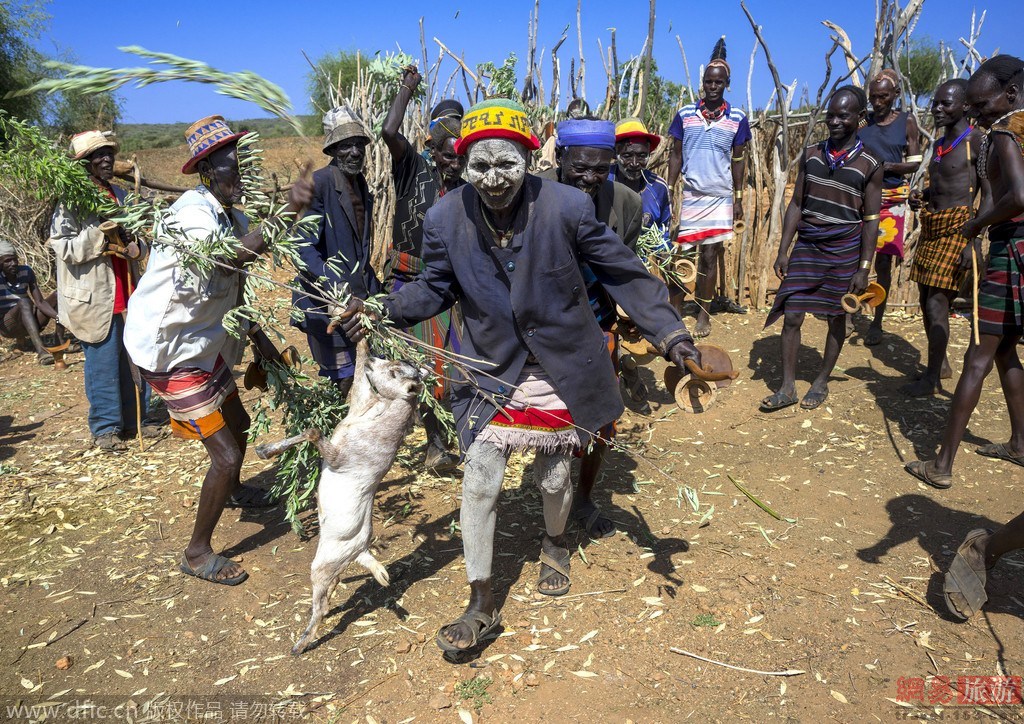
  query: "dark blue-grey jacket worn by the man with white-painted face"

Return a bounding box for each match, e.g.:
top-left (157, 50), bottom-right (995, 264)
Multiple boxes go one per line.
top-left (384, 175), bottom-right (689, 451)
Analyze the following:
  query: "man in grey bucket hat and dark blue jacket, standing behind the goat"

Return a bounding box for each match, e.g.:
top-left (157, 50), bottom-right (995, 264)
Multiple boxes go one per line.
top-left (292, 105), bottom-right (383, 394)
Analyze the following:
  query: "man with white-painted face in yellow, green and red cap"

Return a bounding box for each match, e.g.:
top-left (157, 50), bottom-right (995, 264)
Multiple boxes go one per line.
top-left (344, 98), bottom-right (700, 654)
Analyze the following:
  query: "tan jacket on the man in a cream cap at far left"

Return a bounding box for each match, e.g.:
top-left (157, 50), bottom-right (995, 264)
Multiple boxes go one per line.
top-left (50, 186), bottom-right (145, 344)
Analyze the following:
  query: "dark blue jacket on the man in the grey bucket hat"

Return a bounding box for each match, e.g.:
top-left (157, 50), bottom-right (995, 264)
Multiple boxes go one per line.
top-left (292, 162), bottom-right (383, 337)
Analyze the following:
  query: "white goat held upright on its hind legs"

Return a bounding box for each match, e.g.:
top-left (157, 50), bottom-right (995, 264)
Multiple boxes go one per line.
top-left (256, 341), bottom-right (422, 654)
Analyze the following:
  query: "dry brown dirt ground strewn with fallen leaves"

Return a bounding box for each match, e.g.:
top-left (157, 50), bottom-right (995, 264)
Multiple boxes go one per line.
top-left (0, 296), bottom-right (1024, 723)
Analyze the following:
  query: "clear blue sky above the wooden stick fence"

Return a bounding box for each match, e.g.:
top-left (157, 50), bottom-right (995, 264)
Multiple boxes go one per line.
top-left (37, 0), bottom-right (1024, 123)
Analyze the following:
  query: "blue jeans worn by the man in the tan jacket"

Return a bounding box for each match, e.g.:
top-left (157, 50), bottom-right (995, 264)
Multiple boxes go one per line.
top-left (82, 314), bottom-right (150, 437)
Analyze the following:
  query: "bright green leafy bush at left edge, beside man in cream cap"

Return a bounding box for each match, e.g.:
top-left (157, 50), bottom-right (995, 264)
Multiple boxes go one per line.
top-left (0, 112), bottom-right (117, 216)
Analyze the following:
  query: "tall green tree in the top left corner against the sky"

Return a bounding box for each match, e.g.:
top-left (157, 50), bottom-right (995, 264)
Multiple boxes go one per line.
top-left (0, 0), bottom-right (49, 122)
